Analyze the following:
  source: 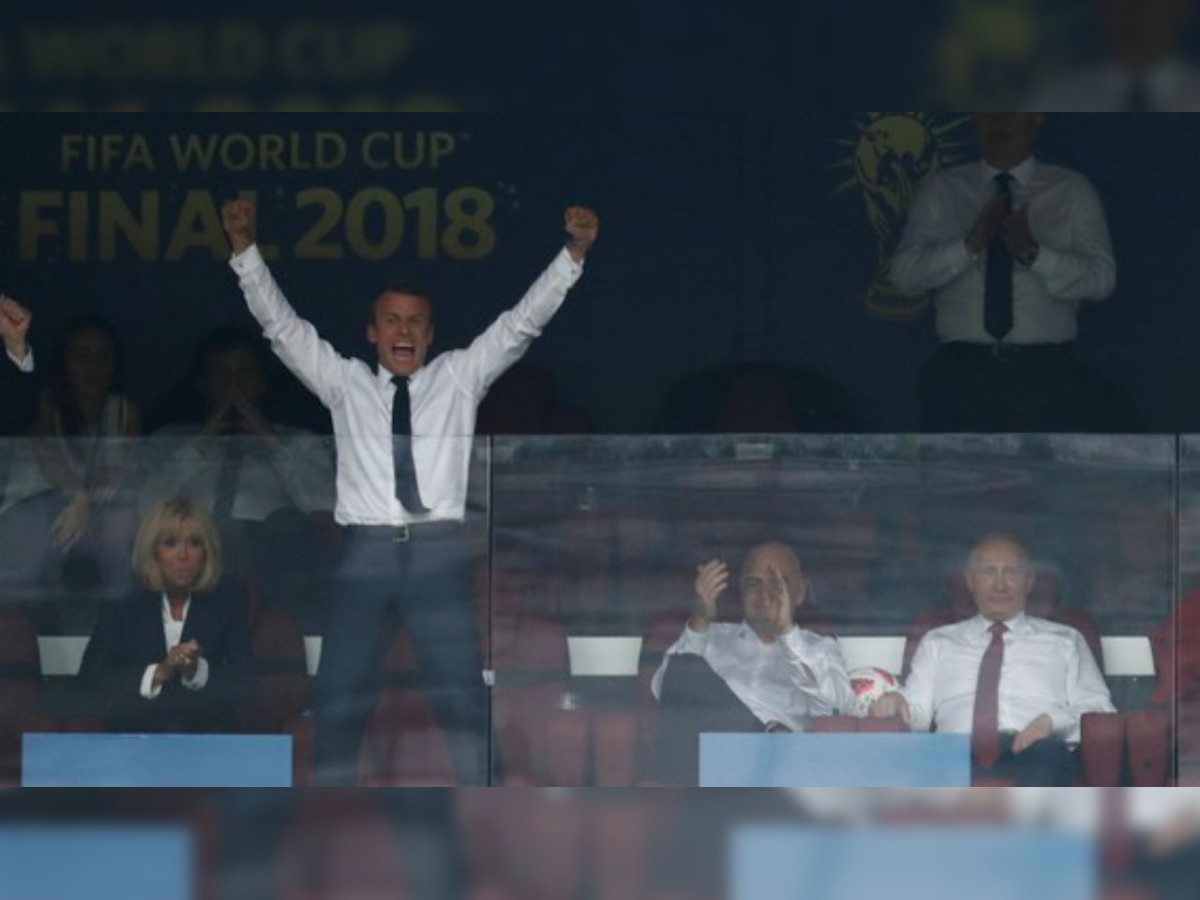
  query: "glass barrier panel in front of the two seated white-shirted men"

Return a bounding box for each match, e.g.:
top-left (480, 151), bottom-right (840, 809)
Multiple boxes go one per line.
top-left (492, 436), bottom-right (1176, 787)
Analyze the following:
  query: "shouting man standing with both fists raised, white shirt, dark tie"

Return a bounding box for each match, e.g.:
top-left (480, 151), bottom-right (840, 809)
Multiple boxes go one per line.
top-left (222, 200), bottom-right (600, 785)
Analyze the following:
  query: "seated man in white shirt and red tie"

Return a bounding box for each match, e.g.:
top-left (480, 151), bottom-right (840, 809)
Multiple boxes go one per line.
top-left (871, 535), bottom-right (1115, 787)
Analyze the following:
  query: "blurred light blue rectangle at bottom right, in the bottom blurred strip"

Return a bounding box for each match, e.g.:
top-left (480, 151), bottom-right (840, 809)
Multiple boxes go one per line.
top-left (730, 826), bottom-right (1099, 900)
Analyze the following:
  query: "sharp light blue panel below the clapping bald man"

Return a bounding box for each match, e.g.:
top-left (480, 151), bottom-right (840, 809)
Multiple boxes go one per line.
top-left (700, 734), bottom-right (971, 787)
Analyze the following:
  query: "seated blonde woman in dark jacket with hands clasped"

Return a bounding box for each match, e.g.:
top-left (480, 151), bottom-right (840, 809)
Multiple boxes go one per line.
top-left (79, 499), bottom-right (254, 733)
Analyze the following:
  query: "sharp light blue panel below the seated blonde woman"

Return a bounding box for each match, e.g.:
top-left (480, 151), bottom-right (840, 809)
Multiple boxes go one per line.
top-left (20, 734), bottom-right (292, 787)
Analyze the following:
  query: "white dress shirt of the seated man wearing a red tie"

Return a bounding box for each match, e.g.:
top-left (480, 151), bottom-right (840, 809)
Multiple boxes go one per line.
top-left (904, 614), bottom-right (1116, 745)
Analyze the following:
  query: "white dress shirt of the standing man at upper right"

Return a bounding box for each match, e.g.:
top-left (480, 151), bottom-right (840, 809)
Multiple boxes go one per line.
top-left (892, 157), bottom-right (1116, 344)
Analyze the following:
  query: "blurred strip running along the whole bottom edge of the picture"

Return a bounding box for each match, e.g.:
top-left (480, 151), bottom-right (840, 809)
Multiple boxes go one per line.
top-left (0, 788), bottom-right (1200, 900)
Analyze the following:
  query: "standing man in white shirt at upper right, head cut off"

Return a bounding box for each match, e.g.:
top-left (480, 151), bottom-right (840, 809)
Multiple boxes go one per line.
top-left (892, 113), bottom-right (1116, 432)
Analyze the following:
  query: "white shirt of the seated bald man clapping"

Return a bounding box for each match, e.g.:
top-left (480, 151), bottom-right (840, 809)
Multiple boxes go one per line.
top-left (650, 623), bottom-right (854, 731)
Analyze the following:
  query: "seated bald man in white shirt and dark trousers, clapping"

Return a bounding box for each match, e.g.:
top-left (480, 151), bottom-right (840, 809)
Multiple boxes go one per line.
top-left (652, 542), bottom-right (854, 784)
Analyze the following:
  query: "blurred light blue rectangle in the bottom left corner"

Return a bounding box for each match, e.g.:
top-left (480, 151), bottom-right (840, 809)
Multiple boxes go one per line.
top-left (0, 824), bottom-right (194, 900)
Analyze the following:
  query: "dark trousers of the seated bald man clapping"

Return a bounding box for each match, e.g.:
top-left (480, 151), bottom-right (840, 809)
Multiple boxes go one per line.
top-left (655, 653), bottom-right (763, 785)
